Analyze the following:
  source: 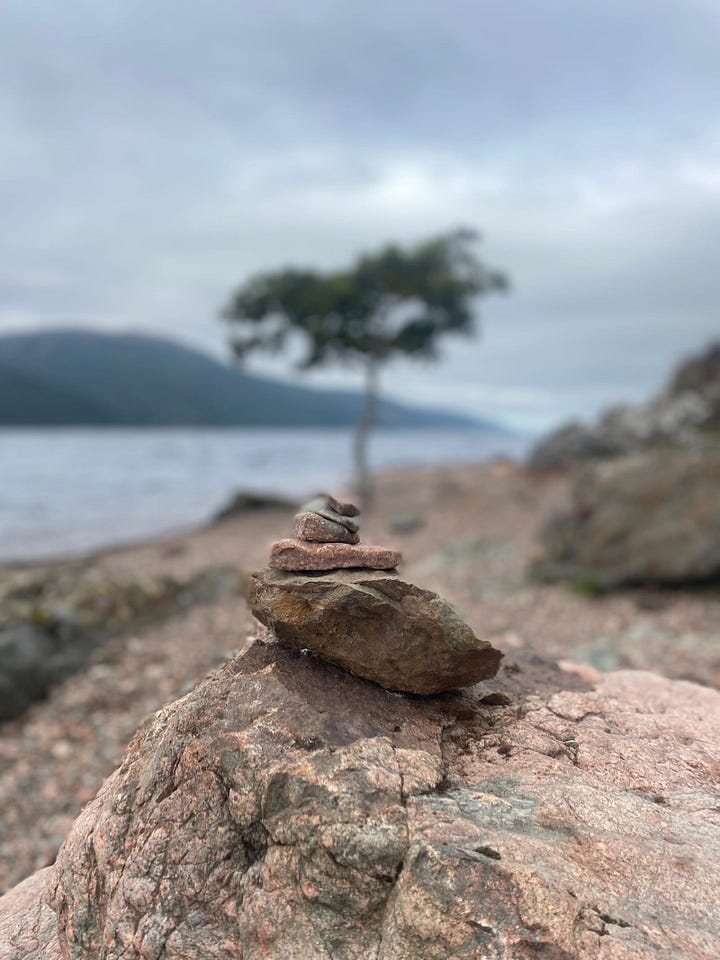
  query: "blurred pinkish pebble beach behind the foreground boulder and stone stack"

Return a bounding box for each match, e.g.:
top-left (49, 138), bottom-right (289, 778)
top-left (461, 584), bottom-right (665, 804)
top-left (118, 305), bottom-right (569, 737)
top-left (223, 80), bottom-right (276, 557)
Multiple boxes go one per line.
top-left (0, 461), bottom-right (720, 891)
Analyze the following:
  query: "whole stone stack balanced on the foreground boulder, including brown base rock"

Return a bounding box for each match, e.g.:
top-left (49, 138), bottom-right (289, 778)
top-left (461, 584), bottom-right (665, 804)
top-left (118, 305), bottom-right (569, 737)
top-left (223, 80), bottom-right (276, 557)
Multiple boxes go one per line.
top-left (248, 496), bottom-right (502, 695)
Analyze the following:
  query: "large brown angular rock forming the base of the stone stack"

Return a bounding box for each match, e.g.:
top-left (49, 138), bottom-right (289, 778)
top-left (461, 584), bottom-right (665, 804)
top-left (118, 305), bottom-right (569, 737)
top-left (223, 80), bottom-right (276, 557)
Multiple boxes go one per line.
top-left (248, 570), bottom-right (502, 695)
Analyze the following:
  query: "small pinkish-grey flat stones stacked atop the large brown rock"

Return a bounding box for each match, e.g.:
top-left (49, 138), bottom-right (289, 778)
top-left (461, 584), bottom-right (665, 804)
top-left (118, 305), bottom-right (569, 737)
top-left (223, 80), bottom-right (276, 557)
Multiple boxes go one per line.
top-left (270, 494), bottom-right (402, 573)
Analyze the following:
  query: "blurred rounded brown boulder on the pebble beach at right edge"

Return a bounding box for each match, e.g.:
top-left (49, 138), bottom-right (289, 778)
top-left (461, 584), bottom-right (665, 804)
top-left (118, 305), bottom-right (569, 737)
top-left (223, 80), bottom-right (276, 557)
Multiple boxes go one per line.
top-left (534, 444), bottom-right (720, 588)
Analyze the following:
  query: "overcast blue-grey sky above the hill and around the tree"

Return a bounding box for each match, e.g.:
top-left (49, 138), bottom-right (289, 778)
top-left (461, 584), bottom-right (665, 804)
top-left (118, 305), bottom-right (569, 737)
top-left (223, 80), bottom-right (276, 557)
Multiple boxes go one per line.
top-left (0, 0), bottom-right (720, 430)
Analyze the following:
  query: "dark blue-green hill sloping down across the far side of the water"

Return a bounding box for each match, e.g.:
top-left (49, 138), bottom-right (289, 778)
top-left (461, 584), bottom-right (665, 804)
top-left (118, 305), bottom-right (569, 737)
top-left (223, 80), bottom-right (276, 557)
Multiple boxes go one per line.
top-left (0, 330), bottom-right (501, 432)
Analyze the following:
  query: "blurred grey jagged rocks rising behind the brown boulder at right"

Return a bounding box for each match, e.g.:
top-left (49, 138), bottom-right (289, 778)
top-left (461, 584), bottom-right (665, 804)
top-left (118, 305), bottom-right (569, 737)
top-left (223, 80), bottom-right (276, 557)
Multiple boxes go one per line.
top-left (530, 344), bottom-right (720, 467)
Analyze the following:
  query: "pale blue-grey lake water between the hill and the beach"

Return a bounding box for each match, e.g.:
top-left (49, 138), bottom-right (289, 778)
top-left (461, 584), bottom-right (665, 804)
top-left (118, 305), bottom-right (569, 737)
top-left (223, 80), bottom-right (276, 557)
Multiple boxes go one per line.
top-left (0, 429), bottom-right (524, 560)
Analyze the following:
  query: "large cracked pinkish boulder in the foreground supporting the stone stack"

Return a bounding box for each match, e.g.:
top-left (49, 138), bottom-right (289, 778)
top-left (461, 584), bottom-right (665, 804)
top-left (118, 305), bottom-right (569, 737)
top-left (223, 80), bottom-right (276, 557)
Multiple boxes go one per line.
top-left (0, 644), bottom-right (720, 960)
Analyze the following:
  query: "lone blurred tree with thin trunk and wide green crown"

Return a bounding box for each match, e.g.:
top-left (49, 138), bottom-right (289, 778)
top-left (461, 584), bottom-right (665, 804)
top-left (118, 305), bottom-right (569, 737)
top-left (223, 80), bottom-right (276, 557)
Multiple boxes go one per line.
top-left (222, 229), bottom-right (508, 504)
